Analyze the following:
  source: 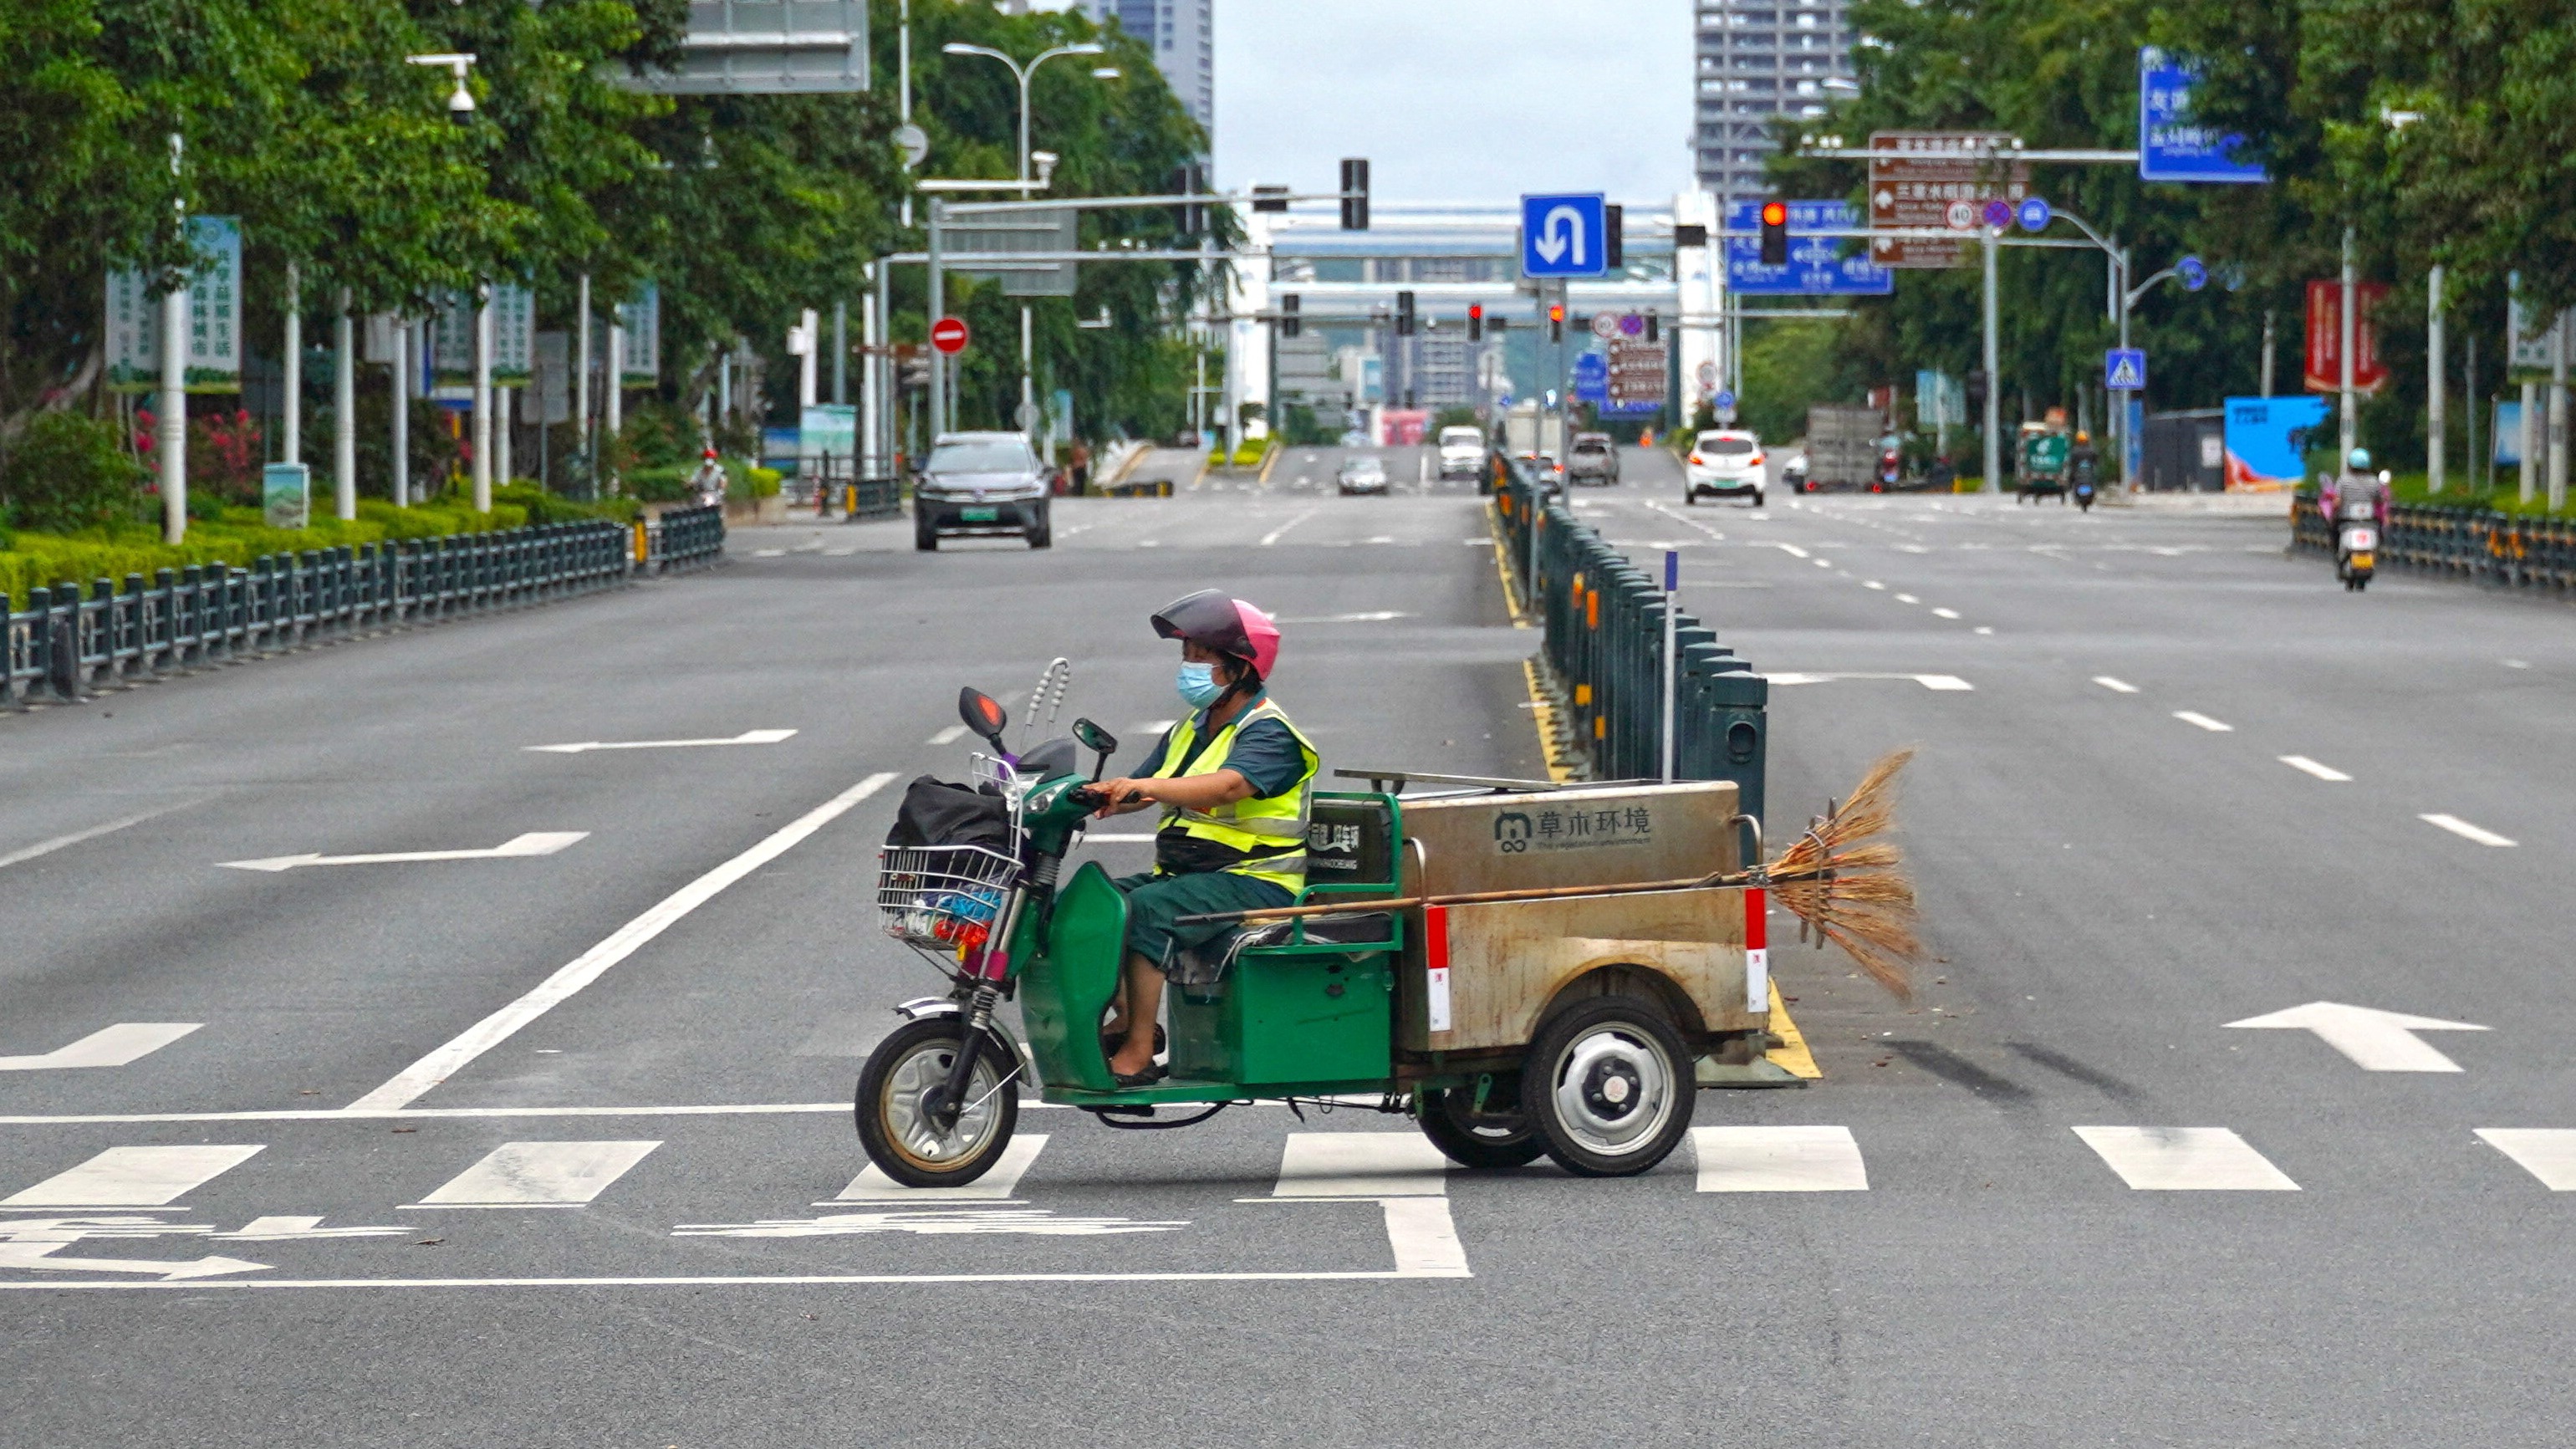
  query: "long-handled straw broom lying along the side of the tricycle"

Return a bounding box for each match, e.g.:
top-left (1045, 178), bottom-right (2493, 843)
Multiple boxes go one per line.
top-left (1175, 747), bottom-right (1921, 1000)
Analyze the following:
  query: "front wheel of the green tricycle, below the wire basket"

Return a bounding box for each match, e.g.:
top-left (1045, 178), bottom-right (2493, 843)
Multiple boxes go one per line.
top-left (858, 1016), bottom-right (1020, 1189)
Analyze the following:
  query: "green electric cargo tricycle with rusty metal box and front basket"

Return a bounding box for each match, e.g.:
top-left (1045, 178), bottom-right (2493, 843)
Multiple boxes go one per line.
top-left (858, 681), bottom-right (1795, 1189)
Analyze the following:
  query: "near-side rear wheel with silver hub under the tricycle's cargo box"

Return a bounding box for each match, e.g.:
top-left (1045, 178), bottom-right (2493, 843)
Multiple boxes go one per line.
top-left (1520, 995), bottom-right (1697, 1178)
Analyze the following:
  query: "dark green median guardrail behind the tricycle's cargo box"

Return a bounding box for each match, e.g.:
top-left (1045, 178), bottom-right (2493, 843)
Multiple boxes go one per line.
top-left (1492, 454), bottom-right (1770, 814)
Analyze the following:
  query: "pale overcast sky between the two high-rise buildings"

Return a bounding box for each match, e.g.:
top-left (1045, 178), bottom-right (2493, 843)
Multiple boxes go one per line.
top-left (1216, 0), bottom-right (1692, 204)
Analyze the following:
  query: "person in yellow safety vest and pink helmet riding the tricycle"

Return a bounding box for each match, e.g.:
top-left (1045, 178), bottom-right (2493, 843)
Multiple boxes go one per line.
top-left (1094, 588), bottom-right (1322, 1085)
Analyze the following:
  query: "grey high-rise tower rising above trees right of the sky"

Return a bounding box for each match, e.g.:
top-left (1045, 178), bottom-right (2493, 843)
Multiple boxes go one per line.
top-left (1695, 0), bottom-right (1854, 202)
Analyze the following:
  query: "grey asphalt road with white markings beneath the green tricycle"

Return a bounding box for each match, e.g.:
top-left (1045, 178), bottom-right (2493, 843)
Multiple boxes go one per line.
top-left (0, 479), bottom-right (2576, 1446)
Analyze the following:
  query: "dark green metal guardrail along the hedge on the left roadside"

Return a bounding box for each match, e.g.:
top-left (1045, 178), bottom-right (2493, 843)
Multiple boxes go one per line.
top-left (0, 508), bottom-right (724, 709)
